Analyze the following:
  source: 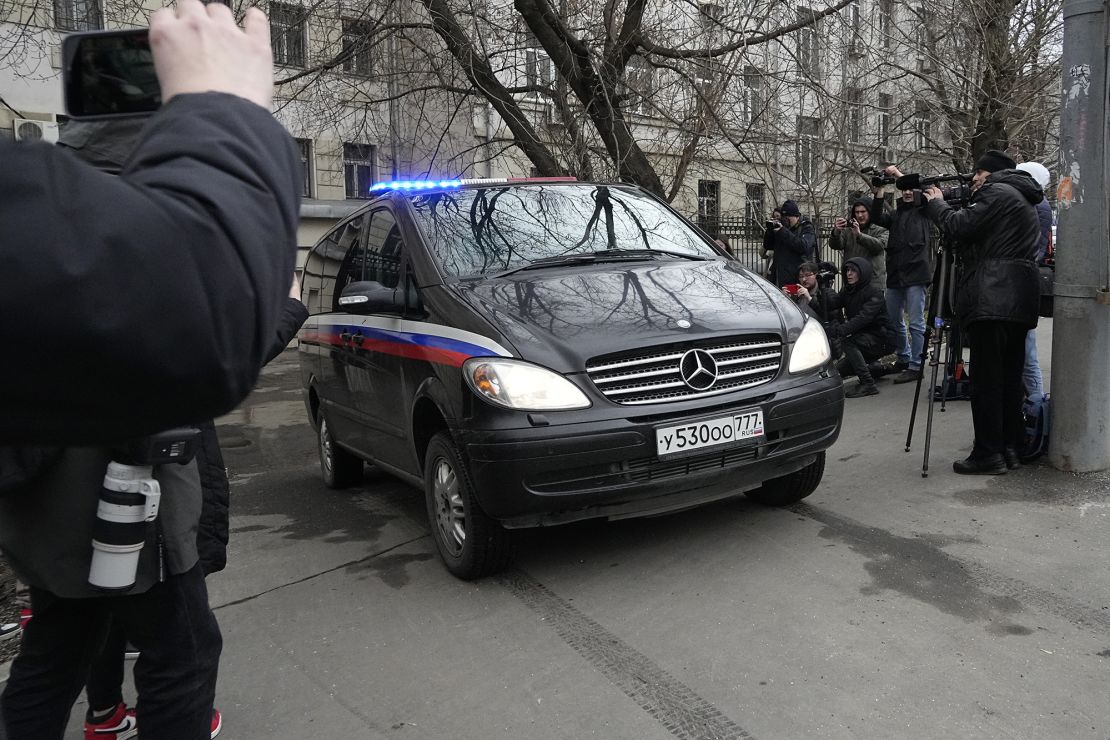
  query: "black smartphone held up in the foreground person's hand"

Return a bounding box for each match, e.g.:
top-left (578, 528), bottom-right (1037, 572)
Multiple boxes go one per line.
top-left (62, 29), bottom-right (162, 119)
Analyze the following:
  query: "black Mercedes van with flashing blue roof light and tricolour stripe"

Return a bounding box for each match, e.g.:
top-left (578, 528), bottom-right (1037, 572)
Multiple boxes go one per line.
top-left (299, 179), bottom-right (844, 579)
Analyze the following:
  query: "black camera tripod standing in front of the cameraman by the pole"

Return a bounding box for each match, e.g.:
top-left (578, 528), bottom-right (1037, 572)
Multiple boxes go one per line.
top-left (906, 242), bottom-right (968, 478)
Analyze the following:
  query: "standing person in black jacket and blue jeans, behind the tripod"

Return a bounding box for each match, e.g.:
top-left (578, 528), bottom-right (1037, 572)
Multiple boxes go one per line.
top-left (871, 164), bottom-right (932, 383)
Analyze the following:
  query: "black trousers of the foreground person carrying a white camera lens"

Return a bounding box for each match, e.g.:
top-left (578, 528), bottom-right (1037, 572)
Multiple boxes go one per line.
top-left (0, 565), bottom-right (223, 740)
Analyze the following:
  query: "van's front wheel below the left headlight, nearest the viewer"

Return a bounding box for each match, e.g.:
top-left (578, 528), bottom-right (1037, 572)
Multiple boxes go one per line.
top-left (424, 432), bottom-right (514, 580)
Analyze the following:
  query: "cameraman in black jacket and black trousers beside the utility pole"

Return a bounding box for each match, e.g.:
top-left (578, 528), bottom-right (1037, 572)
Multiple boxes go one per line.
top-left (925, 150), bottom-right (1043, 475)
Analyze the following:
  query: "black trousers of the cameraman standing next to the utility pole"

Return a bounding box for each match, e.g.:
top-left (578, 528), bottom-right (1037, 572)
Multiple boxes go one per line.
top-left (967, 321), bottom-right (1028, 458)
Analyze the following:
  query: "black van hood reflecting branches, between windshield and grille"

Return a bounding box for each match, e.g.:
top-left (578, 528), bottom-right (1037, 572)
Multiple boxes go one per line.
top-left (456, 260), bottom-right (804, 373)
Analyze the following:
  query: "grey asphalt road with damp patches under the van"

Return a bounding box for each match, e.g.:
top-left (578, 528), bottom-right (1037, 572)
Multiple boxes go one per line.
top-left (68, 322), bottom-right (1110, 740)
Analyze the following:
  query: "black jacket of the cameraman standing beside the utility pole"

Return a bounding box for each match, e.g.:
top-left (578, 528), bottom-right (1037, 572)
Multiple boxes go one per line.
top-left (927, 170), bottom-right (1045, 328)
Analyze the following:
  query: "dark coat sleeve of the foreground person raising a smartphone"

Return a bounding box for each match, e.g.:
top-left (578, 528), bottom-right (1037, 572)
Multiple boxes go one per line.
top-left (0, 93), bottom-right (301, 445)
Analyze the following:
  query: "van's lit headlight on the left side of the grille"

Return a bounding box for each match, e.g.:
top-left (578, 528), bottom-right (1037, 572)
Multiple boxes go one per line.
top-left (463, 359), bottom-right (594, 412)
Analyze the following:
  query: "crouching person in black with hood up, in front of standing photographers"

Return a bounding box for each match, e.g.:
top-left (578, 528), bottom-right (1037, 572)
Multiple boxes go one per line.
top-left (827, 257), bottom-right (896, 398)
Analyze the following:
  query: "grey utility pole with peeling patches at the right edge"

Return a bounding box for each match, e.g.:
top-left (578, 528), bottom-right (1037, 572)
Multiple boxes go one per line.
top-left (1049, 0), bottom-right (1110, 472)
